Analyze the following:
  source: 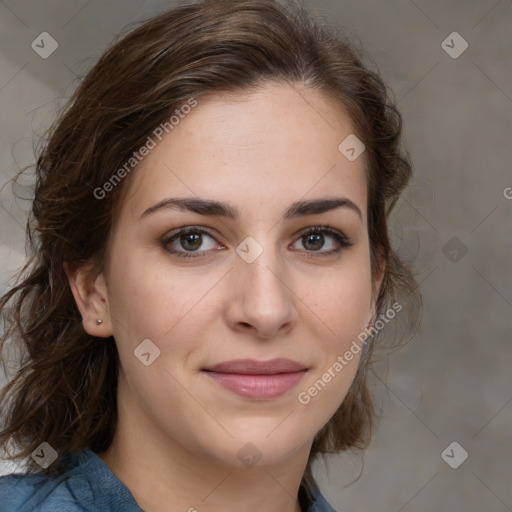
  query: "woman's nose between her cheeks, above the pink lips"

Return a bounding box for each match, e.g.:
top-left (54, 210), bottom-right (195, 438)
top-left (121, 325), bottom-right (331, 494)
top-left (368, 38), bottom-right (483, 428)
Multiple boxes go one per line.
top-left (225, 243), bottom-right (298, 339)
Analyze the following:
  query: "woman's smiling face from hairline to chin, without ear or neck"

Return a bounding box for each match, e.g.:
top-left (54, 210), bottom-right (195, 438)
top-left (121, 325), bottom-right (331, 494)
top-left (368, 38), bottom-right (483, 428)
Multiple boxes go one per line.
top-left (95, 85), bottom-right (380, 466)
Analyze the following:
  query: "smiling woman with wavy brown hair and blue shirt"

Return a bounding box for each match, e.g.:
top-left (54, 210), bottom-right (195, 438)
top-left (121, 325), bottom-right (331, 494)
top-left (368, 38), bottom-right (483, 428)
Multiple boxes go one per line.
top-left (0, 0), bottom-right (420, 512)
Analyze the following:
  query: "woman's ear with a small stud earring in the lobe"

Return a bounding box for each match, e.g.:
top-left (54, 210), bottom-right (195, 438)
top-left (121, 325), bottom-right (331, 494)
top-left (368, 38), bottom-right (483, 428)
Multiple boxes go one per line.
top-left (64, 262), bottom-right (112, 338)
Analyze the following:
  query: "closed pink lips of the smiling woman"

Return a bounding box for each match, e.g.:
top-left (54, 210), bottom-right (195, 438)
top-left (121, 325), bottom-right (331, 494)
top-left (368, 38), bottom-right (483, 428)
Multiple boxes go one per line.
top-left (203, 358), bottom-right (308, 400)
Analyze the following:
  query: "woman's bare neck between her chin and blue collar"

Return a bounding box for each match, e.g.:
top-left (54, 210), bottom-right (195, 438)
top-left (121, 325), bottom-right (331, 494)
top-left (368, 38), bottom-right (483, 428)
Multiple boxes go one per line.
top-left (98, 376), bottom-right (311, 512)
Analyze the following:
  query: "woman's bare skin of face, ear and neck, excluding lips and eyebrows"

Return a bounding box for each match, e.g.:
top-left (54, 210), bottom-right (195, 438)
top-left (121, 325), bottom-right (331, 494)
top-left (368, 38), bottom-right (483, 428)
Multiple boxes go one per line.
top-left (67, 84), bottom-right (380, 512)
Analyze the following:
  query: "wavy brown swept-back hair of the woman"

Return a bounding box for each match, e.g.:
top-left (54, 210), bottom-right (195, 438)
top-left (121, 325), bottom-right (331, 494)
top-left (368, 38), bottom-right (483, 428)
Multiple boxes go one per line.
top-left (0, 0), bottom-right (421, 484)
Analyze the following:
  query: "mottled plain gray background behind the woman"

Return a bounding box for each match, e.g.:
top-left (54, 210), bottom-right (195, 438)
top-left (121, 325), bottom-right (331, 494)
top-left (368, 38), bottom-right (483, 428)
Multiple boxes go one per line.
top-left (0, 0), bottom-right (512, 512)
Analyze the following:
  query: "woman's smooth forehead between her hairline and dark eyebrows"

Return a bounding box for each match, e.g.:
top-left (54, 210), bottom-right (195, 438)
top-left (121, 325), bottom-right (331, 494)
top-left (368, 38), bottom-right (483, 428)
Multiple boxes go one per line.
top-left (123, 84), bottom-right (366, 222)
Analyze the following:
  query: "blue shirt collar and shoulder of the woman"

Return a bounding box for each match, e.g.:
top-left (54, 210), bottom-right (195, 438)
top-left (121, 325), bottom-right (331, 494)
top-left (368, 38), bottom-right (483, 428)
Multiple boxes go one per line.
top-left (0, 450), bottom-right (336, 512)
